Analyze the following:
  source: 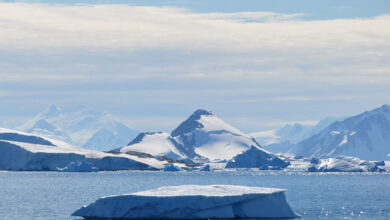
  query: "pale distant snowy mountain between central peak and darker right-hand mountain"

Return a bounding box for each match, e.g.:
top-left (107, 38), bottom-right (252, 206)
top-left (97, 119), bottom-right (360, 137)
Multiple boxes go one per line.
top-left (248, 117), bottom-right (343, 153)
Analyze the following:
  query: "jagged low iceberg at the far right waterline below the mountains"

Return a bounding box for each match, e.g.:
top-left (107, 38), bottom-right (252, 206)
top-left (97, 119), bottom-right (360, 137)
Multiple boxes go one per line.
top-left (307, 156), bottom-right (386, 172)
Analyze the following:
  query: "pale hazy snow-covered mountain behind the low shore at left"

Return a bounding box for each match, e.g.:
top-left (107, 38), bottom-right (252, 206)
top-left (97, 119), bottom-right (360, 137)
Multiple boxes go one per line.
top-left (17, 105), bottom-right (138, 151)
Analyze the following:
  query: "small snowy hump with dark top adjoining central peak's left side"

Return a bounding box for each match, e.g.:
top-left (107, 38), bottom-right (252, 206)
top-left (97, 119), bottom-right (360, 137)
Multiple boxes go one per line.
top-left (119, 132), bottom-right (187, 160)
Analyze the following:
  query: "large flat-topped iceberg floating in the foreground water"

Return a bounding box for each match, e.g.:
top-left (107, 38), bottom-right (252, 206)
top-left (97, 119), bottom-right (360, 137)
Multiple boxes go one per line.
top-left (72, 185), bottom-right (299, 219)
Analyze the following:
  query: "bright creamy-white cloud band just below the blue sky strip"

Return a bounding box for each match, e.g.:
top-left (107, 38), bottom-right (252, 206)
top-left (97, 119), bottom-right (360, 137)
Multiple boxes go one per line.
top-left (0, 3), bottom-right (390, 52)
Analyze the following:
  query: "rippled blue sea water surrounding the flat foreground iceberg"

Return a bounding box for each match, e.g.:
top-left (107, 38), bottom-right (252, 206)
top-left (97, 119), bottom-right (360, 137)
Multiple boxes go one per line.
top-left (0, 170), bottom-right (390, 220)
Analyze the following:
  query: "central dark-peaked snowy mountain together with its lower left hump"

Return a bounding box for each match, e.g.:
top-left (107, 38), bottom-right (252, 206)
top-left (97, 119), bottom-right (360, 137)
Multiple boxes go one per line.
top-left (116, 109), bottom-right (284, 164)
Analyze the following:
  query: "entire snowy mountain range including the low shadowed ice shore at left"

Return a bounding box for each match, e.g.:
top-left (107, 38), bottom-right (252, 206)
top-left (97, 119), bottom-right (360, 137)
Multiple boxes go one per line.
top-left (0, 105), bottom-right (390, 170)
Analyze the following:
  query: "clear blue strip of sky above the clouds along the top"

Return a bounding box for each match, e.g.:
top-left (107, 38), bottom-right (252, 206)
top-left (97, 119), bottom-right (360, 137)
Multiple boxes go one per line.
top-left (5, 0), bottom-right (390, 19)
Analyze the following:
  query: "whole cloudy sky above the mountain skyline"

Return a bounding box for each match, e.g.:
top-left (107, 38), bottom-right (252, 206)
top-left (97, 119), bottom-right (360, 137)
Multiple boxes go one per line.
top-left (0, 0), bottom-right (390, 132)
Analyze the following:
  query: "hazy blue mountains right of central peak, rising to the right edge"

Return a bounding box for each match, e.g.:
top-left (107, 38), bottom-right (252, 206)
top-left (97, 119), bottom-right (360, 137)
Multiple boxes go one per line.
top-left (249, 105), bottom-right (390, 160)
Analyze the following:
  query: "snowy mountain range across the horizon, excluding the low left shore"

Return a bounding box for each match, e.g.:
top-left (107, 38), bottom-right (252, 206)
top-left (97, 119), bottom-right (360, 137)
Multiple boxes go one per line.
top-left (6, 105), bottom-right (390, 161)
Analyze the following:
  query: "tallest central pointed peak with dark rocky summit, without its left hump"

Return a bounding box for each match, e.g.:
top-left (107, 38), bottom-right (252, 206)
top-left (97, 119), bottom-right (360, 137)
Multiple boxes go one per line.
top-left (171, 109), bottom-right (260, 160)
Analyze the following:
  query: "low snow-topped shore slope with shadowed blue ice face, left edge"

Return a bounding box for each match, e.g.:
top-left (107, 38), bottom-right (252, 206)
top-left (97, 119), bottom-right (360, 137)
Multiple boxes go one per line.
top-left (0, 128), bottom-right (166, 171)
